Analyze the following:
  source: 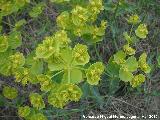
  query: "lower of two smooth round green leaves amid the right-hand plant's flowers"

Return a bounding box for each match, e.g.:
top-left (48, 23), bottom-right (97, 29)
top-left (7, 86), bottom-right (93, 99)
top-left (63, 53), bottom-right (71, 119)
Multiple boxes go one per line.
top-left (119, 68), bottom-right (134, 82)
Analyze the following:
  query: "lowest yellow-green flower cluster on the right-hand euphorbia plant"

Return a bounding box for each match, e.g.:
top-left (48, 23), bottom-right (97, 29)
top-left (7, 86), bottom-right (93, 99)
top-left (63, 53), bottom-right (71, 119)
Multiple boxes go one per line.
top-left (130, 74), bottom-right (145, 87)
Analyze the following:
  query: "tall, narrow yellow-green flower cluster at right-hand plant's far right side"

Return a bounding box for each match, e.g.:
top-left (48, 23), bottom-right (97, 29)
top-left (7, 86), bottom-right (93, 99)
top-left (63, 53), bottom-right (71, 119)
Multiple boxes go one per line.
top-left (138, 53), bottom-right (151, 73)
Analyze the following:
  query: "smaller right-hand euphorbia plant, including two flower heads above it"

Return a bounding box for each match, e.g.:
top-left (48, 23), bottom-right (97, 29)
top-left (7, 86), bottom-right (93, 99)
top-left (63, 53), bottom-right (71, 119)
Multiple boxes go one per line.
top-left (107, 15), bottom-right (151, 87)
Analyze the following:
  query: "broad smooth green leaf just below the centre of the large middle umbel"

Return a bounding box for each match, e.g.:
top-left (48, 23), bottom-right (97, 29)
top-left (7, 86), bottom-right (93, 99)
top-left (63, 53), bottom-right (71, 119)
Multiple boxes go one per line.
top-left (62, 69), bottom-right (83, 84)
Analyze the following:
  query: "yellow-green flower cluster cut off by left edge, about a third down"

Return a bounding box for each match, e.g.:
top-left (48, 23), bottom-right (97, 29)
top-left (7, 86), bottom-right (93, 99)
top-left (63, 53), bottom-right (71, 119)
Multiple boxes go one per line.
top-left (0, 35), bottom-right (8, 52)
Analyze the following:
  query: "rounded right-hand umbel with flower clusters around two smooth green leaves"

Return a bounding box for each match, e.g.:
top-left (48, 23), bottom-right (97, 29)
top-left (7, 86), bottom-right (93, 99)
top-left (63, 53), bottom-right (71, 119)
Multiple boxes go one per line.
top-left (109, 47), bottom-right (151, 87)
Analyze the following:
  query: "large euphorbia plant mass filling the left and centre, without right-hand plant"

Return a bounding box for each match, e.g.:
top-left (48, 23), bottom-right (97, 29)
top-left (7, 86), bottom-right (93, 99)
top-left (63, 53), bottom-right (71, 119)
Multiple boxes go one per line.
top-left (0, 0), bottom-right (106, 120)
